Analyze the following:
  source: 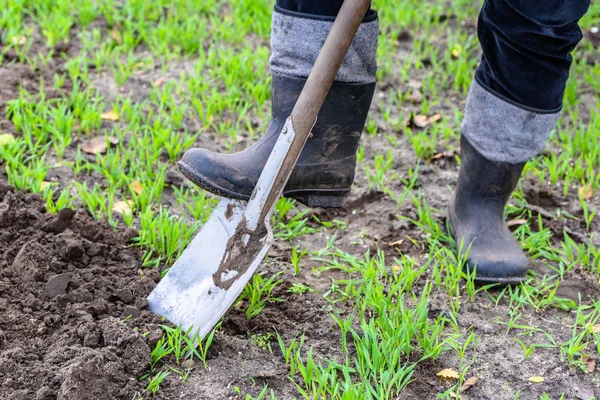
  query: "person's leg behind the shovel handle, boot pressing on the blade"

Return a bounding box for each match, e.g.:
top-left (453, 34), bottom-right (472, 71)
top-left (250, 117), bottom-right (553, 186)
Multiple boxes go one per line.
top-left (179, 0), bottom-right (379, 207)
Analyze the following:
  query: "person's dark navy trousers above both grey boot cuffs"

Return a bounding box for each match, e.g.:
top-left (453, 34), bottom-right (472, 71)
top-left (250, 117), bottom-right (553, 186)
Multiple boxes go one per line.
top-left (277, 0), bottom-right (590, 112)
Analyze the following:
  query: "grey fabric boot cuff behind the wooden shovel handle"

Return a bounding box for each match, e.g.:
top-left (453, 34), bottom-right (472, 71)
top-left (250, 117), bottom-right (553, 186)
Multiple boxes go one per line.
top-left (270, 8), bottom-right (379, 83)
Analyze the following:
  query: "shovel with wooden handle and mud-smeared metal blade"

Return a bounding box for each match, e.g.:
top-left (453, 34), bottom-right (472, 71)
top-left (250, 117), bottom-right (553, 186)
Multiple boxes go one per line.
top-left (148, 0), bottom-right (371, 339)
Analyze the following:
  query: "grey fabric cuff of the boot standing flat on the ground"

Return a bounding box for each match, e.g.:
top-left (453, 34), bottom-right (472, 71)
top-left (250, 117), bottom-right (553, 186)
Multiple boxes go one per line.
top-left (462, 81), bottom-right (561, 164)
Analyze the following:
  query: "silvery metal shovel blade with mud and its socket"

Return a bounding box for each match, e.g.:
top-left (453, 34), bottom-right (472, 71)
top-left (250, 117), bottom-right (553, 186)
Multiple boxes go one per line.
top-left (148, 118), bottom-right (295, 338)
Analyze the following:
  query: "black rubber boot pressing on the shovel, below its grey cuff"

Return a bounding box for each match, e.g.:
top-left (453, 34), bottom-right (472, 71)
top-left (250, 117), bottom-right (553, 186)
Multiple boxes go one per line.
top-left (179, 74), bottom-right (375, 208)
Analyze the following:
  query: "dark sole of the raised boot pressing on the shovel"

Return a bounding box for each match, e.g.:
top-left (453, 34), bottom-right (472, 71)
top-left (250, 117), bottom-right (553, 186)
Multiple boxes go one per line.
top-left (177, 161), bottom-right (350, 208)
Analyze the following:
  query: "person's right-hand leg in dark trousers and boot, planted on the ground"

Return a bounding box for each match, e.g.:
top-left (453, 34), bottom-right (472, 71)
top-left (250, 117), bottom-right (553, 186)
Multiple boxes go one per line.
top-left (448, 0), bottom-right (590, 283)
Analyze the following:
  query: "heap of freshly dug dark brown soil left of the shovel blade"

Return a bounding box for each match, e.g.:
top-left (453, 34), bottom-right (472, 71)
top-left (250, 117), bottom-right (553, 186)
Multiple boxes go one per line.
top-left (0, 179), bottom-right (161, 400)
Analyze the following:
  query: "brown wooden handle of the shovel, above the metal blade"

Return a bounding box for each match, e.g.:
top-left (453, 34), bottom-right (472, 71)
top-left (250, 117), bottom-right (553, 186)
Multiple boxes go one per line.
top-left (261, 0), bottom-right (371, 217)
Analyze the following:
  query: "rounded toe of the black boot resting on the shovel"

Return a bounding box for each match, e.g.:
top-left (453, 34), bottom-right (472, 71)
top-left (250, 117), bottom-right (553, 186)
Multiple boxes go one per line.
top-left (177, 148), bottom-right (254, 200)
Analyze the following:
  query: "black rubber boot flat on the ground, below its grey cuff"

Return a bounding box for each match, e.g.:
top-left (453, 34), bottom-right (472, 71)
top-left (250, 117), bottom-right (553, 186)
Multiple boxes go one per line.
top-left (448, 136), bottom-right (528, 284)
